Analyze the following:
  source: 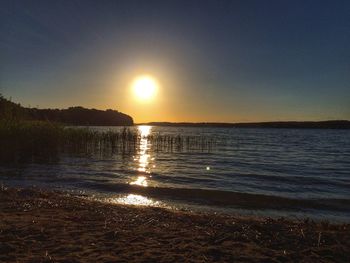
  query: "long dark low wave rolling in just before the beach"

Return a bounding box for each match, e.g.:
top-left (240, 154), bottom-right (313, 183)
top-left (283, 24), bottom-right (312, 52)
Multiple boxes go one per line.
top-left (79, 182), bottom-right (350, 212)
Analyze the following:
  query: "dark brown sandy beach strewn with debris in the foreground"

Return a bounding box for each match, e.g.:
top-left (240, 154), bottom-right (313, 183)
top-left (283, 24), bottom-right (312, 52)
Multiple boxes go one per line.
top-left (0, 187), bottom-right (350, 262)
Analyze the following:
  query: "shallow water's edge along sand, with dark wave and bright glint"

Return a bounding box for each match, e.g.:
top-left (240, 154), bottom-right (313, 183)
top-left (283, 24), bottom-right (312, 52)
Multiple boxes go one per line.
top-left (0, 181), bottom-right (350, 224)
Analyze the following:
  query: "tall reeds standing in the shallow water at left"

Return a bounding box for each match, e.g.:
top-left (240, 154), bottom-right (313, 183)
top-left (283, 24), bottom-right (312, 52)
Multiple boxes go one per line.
top-left (0, 120), bottom-right (216, 163)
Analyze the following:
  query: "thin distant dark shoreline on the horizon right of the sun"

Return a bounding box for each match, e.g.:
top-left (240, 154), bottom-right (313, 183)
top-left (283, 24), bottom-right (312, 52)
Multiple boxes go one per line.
top-left (145, 120), bottom-right (350, 129)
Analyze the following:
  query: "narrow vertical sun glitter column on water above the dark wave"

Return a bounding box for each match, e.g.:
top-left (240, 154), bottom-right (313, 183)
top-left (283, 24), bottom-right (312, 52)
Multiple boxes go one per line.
top-left (130, 125), bottom-right (154, 186)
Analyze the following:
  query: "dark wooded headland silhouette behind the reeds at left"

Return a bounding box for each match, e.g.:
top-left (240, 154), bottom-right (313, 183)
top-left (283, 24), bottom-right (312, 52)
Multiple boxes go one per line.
top-left (0, 94), bottom-right (133, 126)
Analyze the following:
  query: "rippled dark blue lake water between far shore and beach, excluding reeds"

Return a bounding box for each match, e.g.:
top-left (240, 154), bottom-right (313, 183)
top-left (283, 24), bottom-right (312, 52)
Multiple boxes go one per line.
top-left (0, 126), bottom-right (350, 220)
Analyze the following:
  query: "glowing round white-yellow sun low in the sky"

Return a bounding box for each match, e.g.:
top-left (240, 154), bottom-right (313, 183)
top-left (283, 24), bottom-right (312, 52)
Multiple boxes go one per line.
top-left (132, 75), bottom-right (158, 101)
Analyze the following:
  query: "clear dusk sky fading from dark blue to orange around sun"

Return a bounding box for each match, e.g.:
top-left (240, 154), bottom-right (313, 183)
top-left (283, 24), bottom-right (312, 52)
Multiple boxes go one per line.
top-left (0, 0), bottom-right (350, 122)
